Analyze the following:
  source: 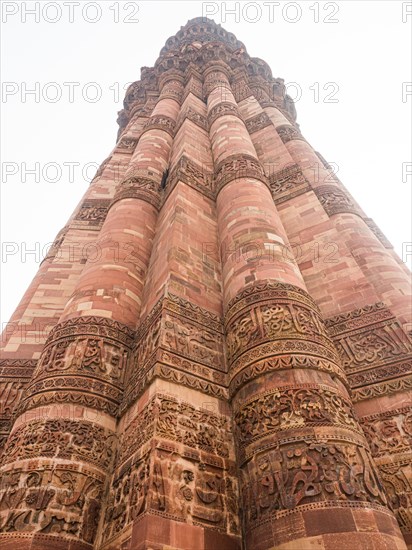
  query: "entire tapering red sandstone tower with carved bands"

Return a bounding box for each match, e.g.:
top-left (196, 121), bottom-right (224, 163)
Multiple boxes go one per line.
top-left (0, 19), bottom-right (412, 550)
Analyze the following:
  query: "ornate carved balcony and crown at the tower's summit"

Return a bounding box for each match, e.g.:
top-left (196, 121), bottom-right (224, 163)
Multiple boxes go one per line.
top-left (118, 17), bottom-right (296, 138)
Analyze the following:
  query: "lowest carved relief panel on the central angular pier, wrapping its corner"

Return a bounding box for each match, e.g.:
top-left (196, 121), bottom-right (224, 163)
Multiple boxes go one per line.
top-left (103, 443), bottom-right (239, 541)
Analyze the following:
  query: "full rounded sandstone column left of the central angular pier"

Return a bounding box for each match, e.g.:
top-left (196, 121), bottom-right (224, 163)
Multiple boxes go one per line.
top-left (0, 72), bottom-right (182, 550)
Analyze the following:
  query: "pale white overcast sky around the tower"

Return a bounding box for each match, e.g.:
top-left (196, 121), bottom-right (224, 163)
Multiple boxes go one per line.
top-left (0, 0), bottom-right (412, 323)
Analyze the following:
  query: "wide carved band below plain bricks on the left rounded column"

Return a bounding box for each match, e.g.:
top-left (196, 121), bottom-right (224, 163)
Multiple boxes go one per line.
top-left (17, 317), bottom-right (134, 410)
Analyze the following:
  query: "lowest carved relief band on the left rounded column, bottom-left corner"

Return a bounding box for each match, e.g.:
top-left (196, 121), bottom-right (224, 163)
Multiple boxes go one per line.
top-left (0, 462), bottom-right (104, 544)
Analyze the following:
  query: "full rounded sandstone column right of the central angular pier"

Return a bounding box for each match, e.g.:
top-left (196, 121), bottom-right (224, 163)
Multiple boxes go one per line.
top-left (205, 64), bottom-right (403, 550)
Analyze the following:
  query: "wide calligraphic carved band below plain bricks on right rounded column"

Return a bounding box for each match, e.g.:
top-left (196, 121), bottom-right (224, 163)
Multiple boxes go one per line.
top-left (226, 282), bottom-right (342, 390)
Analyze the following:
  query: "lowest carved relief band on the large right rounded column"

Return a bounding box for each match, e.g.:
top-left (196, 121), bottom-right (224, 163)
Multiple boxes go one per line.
top-left (241, 438), bottom-right (387, 523)
